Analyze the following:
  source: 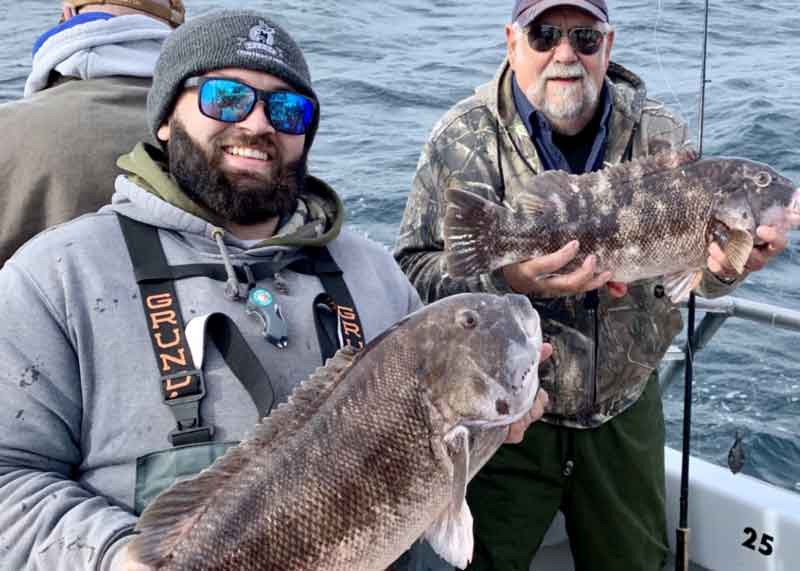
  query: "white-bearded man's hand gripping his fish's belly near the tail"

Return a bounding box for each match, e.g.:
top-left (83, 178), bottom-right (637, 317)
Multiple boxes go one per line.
top-left (503, 240), bottom-right (611, 298)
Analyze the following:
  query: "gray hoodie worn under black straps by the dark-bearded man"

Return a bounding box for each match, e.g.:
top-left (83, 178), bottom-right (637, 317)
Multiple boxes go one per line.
top-left (0, 146), bottom-right (421, 571)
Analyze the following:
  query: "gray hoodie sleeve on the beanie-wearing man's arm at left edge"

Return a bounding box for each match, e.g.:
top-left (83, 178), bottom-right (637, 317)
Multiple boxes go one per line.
top-left (0, 261), bottom-right (136, 571)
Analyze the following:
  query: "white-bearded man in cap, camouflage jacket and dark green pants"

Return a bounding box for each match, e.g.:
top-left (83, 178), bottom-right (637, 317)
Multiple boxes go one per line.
top-left (395, 0), bottom-right (786, 571)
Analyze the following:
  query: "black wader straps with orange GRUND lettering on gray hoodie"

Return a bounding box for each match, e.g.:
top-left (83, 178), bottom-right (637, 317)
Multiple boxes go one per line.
top-left (117, 213), bottom-right (364, 446)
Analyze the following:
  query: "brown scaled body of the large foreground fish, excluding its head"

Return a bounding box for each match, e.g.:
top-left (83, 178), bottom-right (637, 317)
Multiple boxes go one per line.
top-left (152, 336), bottom-right (449, 571)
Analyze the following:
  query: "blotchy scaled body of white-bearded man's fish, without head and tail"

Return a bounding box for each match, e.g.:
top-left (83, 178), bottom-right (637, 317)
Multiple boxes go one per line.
top-left (495, 149), bottom-right (716, 282)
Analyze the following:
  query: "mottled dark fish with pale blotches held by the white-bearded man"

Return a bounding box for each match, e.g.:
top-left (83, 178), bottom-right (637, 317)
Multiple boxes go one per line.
top-left (444, 148), bottom-right (800, 302)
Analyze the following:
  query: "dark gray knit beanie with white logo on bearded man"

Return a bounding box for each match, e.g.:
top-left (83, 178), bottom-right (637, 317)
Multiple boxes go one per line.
top-left (147, 10), bottom-right (319, 148)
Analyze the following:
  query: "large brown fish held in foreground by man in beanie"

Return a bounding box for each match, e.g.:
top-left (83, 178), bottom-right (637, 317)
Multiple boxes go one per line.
top-left (130, 294), bottom-right (541, 571)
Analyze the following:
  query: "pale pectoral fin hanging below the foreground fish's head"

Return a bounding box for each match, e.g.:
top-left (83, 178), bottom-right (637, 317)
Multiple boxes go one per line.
top-left (424, 427), bottom-right (475, 569)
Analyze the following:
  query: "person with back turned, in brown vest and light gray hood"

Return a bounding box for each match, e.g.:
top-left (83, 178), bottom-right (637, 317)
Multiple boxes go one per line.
top-left (0, 0), bottom-right (184, 267)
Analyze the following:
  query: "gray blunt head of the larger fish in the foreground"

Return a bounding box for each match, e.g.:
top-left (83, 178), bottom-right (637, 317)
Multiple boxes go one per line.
top-left (416, 294), bottom-right (542, 438)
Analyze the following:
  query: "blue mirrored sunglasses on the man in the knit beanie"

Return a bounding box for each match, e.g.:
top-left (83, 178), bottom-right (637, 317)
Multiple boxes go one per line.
top-left (183, 77), bottom-right (316, 135)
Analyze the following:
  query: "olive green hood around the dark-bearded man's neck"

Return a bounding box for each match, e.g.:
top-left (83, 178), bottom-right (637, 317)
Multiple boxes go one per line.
top-left (117, 143), bottom-right (344, 247)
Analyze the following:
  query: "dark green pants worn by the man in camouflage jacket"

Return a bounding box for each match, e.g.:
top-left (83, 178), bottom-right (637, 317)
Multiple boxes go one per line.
top-left (467, 375), bottom-right (668, 571)
